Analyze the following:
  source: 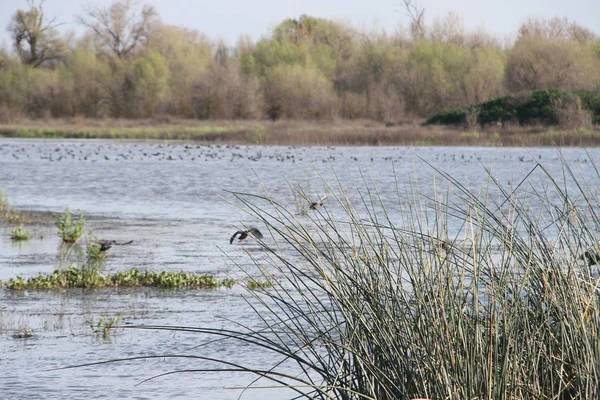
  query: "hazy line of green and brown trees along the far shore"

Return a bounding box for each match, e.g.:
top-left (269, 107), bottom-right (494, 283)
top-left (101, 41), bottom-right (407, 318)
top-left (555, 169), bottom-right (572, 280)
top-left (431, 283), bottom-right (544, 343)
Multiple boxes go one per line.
top-left (0, 0), bottom-right (600, 122)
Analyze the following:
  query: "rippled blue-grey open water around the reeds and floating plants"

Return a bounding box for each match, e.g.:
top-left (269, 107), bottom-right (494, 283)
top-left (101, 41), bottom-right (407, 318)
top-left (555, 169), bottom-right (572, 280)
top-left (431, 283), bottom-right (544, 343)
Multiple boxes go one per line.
top-left (0, 139), bottom-right (600, 399)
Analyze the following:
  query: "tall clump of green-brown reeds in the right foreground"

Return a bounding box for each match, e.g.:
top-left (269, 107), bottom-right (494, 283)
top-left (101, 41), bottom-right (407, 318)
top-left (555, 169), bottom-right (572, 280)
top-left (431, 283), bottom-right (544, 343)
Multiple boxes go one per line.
top-left (77, 156), bottom-right (600, 400)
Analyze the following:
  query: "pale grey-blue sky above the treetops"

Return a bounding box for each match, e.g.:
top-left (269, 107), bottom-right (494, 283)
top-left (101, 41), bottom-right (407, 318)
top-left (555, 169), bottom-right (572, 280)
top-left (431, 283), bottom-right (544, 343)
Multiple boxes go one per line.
top-left (0, 0), bottom-right (600, 45)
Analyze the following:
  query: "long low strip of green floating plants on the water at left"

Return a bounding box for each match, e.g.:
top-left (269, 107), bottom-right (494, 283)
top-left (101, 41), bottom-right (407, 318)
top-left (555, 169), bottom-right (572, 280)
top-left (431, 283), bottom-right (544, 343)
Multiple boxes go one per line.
top-left (4, 266), bottom-right (235, 290)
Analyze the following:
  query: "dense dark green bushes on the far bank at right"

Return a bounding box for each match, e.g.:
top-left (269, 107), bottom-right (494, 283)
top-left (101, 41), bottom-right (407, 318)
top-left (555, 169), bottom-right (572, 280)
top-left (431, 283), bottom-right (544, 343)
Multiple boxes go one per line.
top-left (427, 89), bottom-right (600, 125)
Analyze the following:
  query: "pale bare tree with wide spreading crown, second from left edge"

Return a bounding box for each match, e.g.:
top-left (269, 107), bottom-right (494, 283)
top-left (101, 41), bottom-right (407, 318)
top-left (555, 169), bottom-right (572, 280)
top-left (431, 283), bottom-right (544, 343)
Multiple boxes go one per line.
top-left (77, 0), bottom-right (158, 58)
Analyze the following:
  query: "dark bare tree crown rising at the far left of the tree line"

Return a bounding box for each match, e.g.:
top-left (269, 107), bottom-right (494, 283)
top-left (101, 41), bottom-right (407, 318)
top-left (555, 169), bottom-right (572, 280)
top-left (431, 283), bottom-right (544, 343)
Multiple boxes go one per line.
top-left (8, 0), bottom-right (67, 67)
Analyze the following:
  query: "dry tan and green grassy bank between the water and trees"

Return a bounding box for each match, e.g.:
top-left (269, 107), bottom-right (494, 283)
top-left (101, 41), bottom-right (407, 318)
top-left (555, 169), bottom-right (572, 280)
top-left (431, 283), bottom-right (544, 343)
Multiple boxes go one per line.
top-left (0, 117), bottom-right (600, 147)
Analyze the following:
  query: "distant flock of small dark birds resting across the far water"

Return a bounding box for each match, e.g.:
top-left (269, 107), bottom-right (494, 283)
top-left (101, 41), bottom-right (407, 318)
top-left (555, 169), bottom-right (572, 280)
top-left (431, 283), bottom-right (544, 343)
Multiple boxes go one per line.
top-left (0, 141), bottom-right (588, 163)
